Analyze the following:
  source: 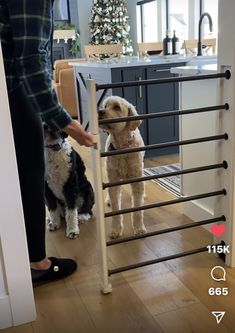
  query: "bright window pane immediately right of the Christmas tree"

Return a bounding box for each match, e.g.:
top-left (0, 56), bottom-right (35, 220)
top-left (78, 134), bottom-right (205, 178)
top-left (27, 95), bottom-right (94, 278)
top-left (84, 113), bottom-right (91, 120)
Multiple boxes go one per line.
top-left (137, 0), bottom-right (158, 43)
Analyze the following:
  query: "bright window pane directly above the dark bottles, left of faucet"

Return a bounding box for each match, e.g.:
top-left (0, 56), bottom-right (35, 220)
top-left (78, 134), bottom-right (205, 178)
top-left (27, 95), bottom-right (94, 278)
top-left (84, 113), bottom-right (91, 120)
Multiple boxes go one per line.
top-left (168, 0), bottom-right (189, 40)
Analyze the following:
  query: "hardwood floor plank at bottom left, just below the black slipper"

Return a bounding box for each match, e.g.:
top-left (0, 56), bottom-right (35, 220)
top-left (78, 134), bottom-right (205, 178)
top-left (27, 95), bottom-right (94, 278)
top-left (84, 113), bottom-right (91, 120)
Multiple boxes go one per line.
top-left (32, 277), bottom-right (97, 333)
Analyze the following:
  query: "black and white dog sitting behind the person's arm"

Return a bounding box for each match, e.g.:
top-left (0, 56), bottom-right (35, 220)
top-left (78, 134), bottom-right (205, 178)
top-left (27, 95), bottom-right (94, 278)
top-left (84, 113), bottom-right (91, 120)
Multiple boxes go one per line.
top-left (44, 124), bottom-right (95, 239)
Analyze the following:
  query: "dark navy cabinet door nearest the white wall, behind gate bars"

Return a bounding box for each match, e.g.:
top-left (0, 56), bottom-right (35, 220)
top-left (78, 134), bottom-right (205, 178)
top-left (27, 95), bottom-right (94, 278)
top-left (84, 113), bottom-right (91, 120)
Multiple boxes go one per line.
top-left (147, 64), bottom-right (179, 156)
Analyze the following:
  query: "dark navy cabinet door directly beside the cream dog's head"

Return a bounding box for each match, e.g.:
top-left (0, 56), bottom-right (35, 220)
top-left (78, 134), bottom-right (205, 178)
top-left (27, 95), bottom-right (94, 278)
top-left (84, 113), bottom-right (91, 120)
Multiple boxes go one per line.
top-left (122, 68), bottom-right (147, 144)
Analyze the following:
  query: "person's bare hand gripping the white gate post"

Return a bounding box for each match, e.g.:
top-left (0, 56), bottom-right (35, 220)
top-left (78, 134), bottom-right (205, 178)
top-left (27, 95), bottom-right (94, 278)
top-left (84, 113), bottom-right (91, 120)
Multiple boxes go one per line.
top-left (63, 120), bottom-right (94, 147)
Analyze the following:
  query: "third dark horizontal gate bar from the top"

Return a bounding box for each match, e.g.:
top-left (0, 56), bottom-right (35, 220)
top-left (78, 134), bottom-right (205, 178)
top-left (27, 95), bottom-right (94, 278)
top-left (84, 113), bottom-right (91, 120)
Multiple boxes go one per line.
top-left (100, 133), bottom-right (228, 157)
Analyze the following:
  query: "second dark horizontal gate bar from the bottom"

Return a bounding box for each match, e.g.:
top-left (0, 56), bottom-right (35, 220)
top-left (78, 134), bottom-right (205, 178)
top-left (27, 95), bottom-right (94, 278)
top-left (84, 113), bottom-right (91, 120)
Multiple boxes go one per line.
top-left (106, 215), bottom-right (226, 246)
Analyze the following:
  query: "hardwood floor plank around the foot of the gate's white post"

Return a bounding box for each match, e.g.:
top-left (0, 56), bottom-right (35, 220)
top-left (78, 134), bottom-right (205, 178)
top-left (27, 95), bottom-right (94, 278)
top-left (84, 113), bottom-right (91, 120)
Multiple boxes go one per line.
top-left (70, 266), bottom-right (164, 333)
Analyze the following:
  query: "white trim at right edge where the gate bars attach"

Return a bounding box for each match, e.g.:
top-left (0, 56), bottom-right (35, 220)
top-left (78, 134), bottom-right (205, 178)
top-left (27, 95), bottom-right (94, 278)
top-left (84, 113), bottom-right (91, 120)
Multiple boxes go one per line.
top-left (218, 0), bottom-right (235, 267)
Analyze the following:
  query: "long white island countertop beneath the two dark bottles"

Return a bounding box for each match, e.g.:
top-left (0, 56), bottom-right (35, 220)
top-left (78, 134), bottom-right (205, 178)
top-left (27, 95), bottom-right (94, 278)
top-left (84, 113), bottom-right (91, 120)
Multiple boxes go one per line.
top-left (69, 55), bottom-right (216, 68)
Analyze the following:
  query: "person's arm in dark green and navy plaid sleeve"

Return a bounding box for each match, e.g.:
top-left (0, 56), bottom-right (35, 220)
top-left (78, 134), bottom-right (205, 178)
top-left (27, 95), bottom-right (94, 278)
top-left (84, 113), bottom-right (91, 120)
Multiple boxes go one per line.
top-left (7, 0), bottom-right (72, 130)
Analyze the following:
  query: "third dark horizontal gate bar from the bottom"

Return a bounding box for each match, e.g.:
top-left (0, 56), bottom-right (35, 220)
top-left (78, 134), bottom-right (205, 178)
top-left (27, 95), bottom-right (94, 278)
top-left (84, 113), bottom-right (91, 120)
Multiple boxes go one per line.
top-left (104, 189), bottom-right (226, 217)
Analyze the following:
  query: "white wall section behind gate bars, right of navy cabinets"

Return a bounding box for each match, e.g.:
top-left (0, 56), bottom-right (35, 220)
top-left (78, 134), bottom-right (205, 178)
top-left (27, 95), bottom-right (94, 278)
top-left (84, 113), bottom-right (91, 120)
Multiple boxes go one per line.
top-left (180, 80), bottom-right (218, 224)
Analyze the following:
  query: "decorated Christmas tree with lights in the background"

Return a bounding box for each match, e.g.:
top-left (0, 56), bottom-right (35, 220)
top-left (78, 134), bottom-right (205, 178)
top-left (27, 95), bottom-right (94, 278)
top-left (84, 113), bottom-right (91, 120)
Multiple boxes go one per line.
top-left (90, 0), bottom-right (133, 55)
